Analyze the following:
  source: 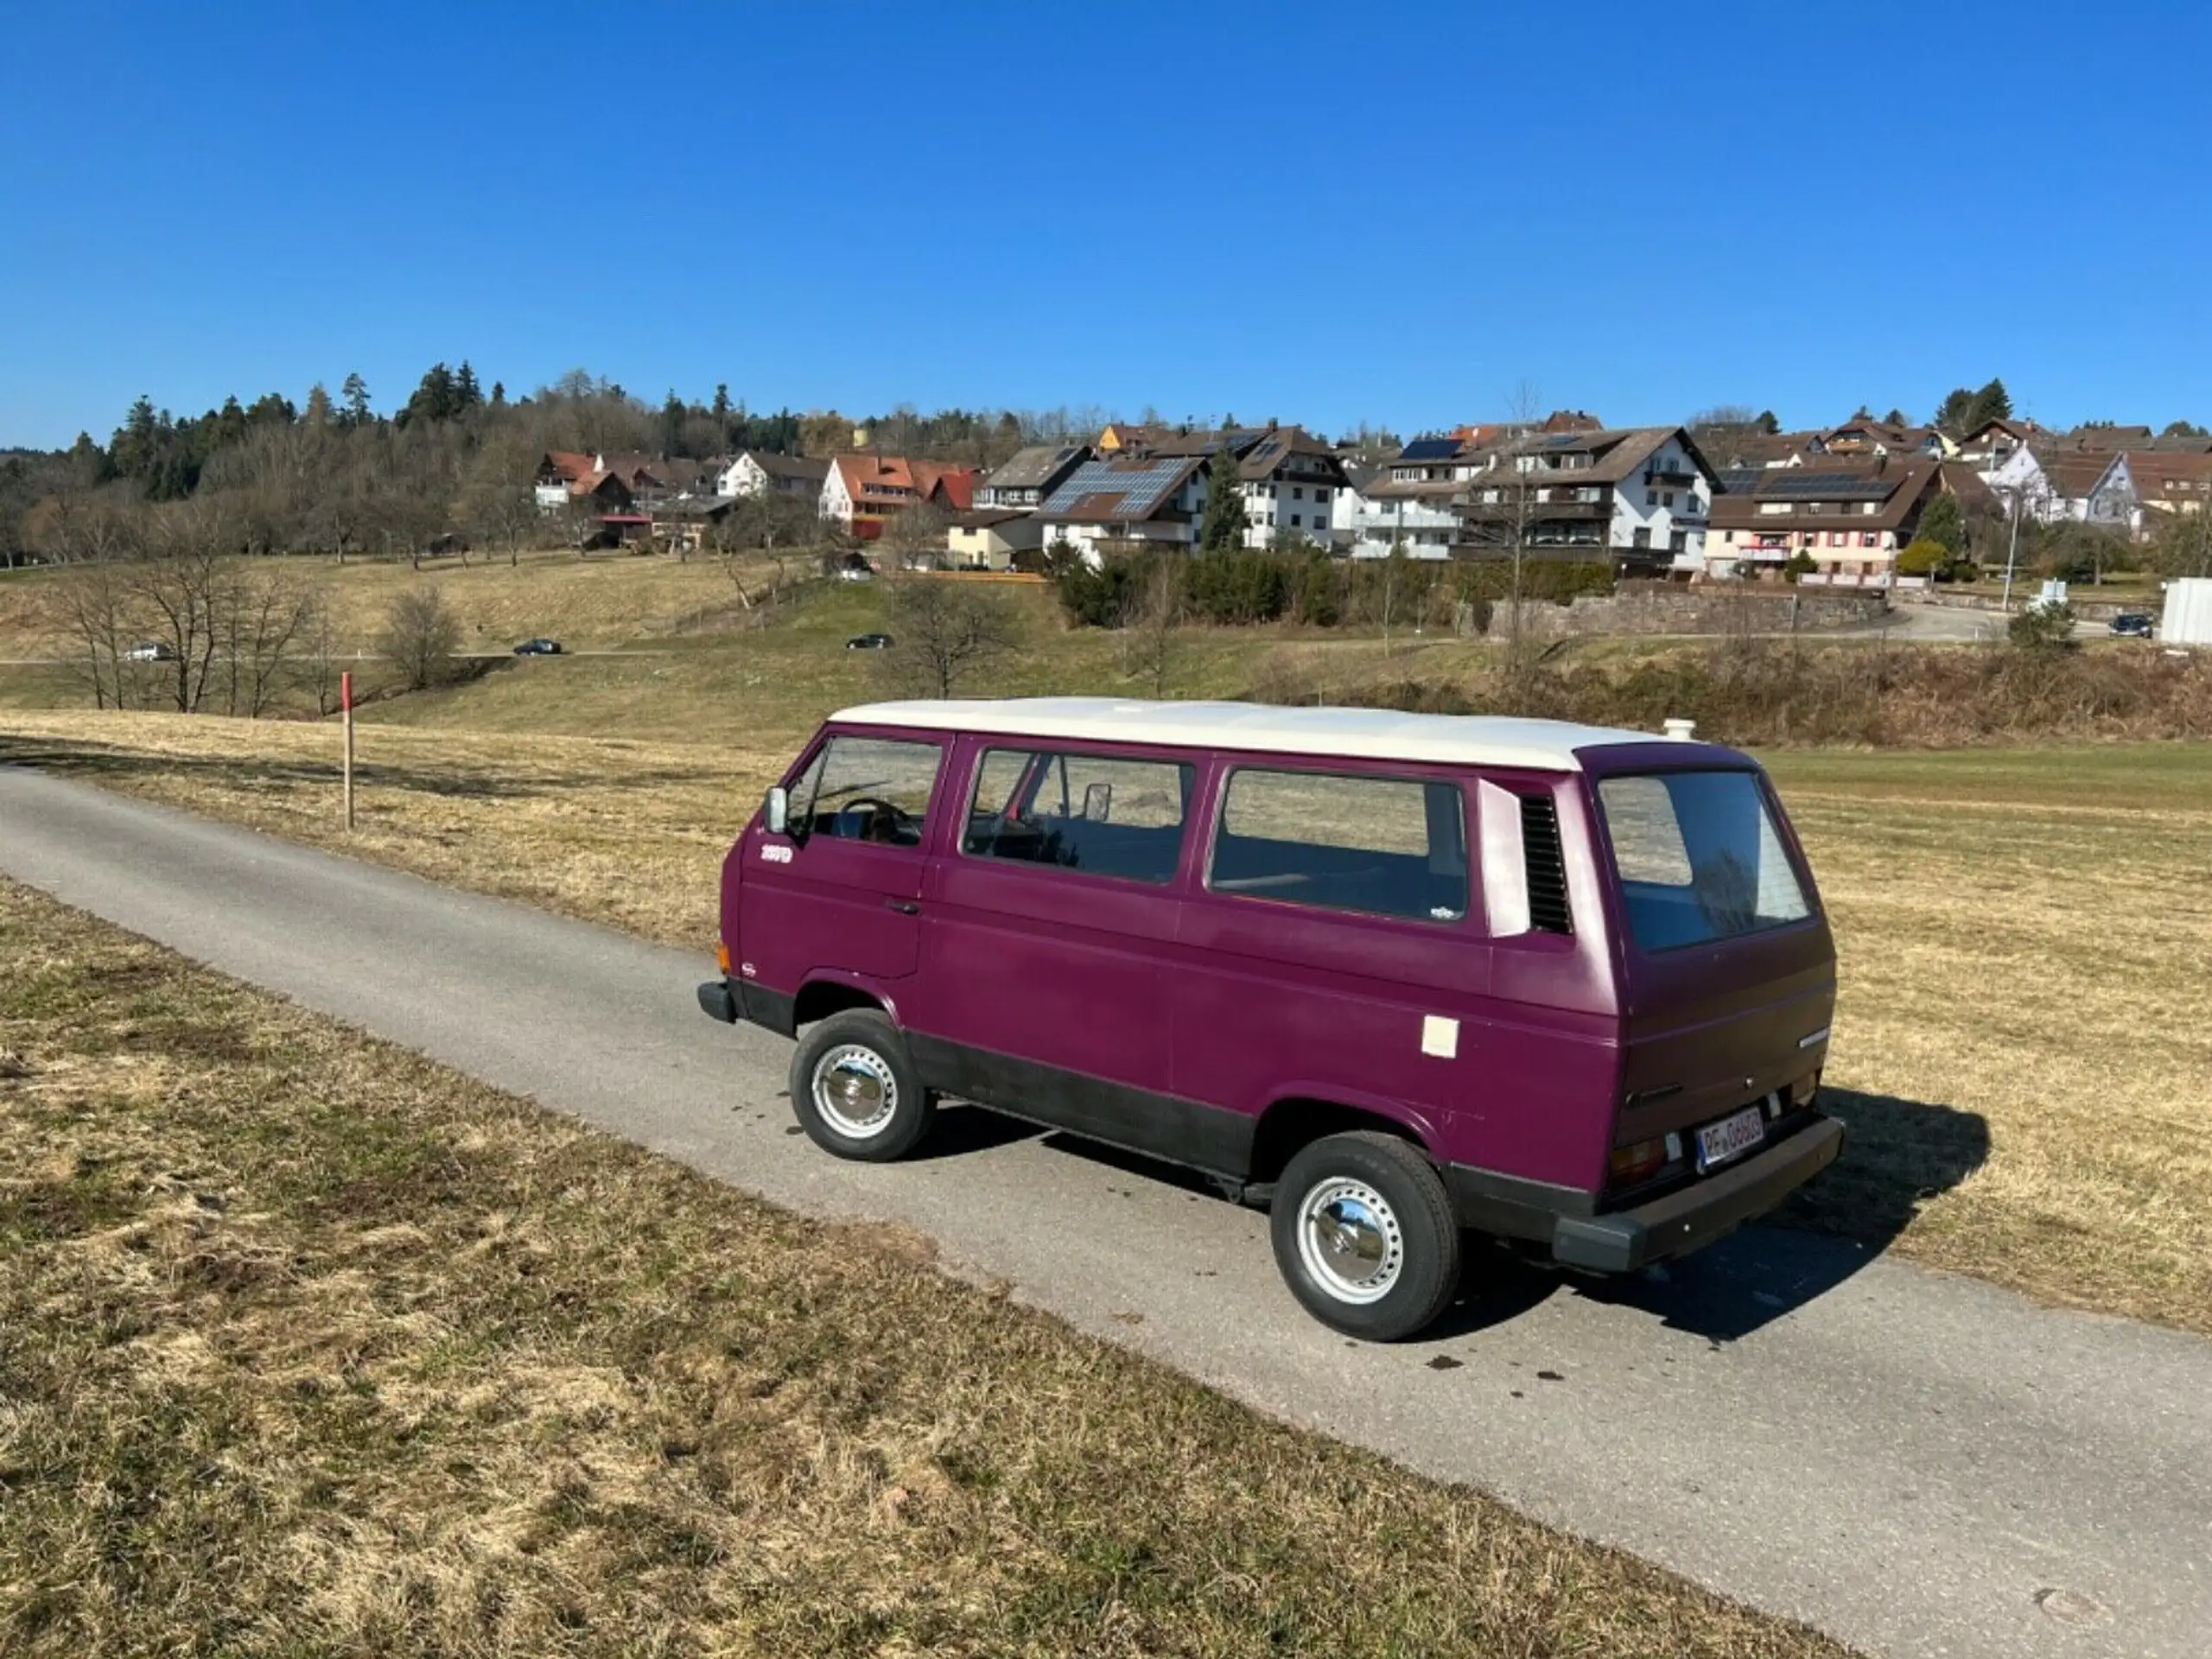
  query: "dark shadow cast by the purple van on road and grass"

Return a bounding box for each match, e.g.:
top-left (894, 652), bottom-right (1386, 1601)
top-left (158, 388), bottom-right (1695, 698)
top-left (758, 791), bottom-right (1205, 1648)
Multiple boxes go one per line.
top-left (918, 1089), bottom-right (1988, 1344)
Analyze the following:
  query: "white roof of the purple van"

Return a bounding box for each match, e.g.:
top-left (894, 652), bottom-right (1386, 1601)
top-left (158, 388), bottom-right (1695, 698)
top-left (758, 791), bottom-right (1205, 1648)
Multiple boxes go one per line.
top-left (830, 696), bottom-right (1663, 772)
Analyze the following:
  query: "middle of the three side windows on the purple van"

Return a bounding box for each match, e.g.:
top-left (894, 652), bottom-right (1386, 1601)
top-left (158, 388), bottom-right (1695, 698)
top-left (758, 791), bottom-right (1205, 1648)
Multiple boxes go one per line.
top-left (960, 750), bottom-right (1194, 882)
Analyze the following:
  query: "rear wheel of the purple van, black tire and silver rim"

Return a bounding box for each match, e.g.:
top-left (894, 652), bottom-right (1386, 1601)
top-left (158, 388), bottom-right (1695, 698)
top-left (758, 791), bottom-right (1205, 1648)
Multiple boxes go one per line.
top-left (1268, 1130), bottom-right (1460, 1343)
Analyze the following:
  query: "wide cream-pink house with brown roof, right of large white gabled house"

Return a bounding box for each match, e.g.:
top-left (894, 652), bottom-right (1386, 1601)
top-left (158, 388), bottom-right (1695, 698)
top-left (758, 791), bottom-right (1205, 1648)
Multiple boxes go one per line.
top-left (1703, 455), bottom-right (1942, 588)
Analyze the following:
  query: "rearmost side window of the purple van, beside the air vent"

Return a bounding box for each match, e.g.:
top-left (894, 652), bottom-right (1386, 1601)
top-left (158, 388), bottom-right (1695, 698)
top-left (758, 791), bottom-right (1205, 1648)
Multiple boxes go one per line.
top-left (1205, 767), bottom-right (1466, 923)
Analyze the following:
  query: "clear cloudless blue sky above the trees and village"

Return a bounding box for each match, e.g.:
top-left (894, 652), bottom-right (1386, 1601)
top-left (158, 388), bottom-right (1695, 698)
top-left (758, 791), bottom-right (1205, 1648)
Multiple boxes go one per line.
top-left (0, 0), bottom-right (2212, 445)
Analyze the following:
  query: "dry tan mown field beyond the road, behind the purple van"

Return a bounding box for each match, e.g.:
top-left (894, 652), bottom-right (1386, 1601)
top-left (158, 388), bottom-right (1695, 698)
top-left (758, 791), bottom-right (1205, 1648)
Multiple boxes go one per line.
top-left (0, 715), bottom-right (2212, 1332)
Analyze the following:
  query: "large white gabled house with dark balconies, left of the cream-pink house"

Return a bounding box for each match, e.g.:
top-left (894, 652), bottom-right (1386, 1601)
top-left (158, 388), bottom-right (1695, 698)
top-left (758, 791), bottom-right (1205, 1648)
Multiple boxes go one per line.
top-left (1451, 427), bottom-right (1719, 575)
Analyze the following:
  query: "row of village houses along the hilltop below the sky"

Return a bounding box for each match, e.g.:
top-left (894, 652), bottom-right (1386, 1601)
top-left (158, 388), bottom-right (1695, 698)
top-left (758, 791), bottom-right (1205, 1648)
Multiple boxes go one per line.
top-left (537, 410), bottom-right (2212, 586)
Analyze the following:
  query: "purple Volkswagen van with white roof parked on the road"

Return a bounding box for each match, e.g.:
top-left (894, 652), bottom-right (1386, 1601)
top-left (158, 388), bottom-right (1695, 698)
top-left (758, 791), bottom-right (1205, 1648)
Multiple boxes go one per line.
top-left (699, 696), bottom-right (1842, 1340)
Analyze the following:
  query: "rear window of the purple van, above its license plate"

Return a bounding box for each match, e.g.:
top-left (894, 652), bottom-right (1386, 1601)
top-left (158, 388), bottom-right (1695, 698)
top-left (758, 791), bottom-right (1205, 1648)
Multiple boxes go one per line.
top-left (1597, 772), bottom-right (1812, 951)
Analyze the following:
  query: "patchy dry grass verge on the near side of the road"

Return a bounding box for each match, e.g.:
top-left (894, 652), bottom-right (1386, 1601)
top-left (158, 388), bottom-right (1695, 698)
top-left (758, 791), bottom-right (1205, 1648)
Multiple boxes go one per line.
top-left (0, 885), bottom-right (1840, 1659)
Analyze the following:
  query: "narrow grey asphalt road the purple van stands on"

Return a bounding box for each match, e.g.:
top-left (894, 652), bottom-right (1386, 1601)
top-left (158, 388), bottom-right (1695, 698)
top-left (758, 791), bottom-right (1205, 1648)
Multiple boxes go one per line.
top-left (0, 767), bottom-right (2212, 1659)
